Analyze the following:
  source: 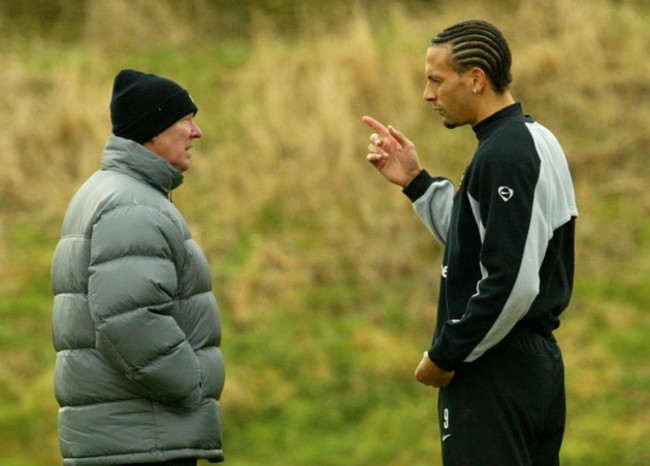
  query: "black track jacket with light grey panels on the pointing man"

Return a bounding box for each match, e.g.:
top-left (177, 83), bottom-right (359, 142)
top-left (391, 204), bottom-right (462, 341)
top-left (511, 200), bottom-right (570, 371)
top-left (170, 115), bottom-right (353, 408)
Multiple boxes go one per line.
top-left (404, 103), bottom-right (578, 370)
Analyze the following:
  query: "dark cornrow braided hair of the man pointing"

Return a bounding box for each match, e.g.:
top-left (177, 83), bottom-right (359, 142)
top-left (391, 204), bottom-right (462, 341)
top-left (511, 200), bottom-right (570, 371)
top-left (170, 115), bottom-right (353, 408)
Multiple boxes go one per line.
top-left (429, 19), bottom-right (512, 94)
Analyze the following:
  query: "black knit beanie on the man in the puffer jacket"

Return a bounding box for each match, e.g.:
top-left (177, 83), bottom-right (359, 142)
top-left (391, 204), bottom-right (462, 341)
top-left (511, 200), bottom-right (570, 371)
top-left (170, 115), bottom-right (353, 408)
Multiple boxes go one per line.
top-left (111, 69), bottom-right (197, 144)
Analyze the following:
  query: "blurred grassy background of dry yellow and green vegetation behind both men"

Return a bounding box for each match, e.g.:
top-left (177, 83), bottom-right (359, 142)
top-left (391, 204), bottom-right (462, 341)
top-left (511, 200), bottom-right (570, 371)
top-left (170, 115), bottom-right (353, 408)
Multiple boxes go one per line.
top-left (0, 0), bottom-right (650, 466)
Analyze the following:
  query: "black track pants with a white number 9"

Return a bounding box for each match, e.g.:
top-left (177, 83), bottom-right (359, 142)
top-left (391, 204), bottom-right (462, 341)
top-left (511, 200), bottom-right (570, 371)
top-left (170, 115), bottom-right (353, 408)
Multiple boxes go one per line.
top-left (438, 330), bottom-right (566, 466)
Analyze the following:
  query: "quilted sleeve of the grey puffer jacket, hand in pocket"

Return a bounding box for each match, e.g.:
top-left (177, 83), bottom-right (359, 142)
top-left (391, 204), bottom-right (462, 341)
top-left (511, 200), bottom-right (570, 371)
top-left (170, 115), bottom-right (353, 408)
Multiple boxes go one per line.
top-left (88, 205), bottom-right (201, 409)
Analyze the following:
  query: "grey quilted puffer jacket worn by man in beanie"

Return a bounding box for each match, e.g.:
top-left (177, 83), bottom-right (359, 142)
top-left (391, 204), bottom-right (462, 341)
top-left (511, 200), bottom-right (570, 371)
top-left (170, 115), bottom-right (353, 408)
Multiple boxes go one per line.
top-left (51, 136), bottom-right (225, 466)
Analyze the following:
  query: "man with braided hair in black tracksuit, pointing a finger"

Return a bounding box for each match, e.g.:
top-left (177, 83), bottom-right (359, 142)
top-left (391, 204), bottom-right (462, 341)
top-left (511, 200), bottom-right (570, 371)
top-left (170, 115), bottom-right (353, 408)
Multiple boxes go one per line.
top-left (364, 20), bottom-right (578, 466)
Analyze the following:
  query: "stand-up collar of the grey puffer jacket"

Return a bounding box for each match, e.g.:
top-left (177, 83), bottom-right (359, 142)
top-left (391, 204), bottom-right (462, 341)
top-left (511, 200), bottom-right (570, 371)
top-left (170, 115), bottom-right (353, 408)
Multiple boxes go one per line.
top-left (101, 136), bottom-right (183, 195)
